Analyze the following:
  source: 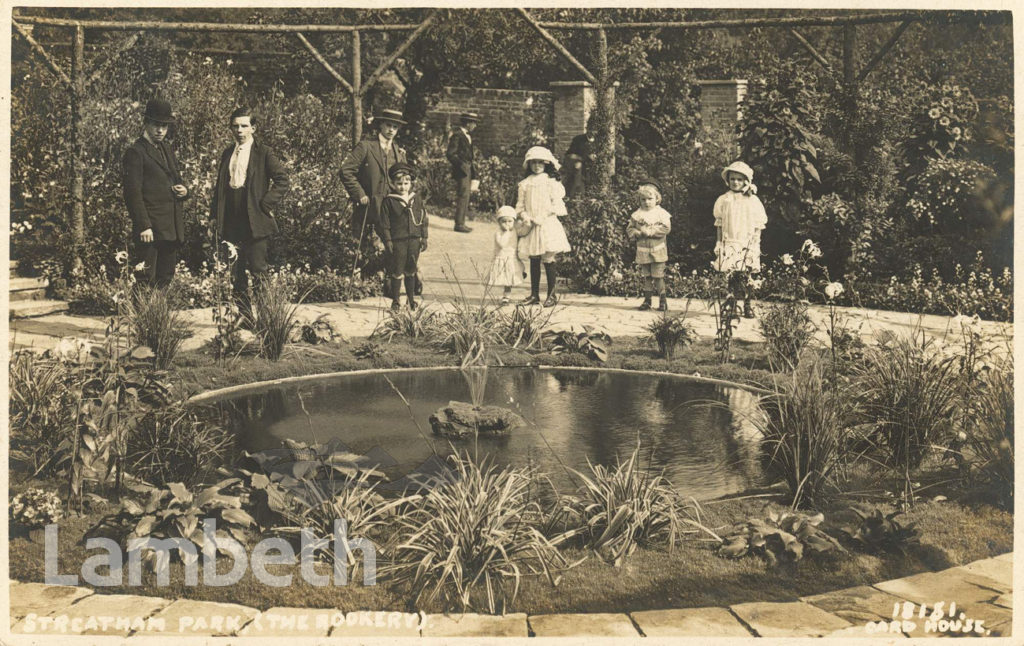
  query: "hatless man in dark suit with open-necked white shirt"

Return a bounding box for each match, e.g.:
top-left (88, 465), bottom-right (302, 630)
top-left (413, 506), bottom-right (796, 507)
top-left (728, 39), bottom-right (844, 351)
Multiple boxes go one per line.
top-left (210, 107), bottom-right (290, 314)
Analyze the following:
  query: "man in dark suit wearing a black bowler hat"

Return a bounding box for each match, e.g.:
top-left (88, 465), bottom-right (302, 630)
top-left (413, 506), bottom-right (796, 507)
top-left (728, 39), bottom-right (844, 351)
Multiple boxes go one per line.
top-left (122, 98), bottom-right (188, 287)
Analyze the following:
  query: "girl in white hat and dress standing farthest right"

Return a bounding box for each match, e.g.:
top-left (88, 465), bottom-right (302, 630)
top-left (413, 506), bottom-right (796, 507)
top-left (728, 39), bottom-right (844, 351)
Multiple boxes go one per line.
top-left (712, 162), bottom-right (768, 318)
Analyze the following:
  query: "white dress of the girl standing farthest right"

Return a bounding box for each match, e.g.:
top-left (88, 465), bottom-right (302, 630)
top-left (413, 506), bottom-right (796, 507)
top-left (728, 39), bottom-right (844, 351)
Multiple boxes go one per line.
top-left (714, 190), bottom-right (768, 271)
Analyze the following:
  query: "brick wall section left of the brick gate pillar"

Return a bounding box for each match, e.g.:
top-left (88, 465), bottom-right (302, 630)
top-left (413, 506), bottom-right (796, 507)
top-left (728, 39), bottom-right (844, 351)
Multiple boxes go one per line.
top-left (427, 87), bottom-right (554, 155)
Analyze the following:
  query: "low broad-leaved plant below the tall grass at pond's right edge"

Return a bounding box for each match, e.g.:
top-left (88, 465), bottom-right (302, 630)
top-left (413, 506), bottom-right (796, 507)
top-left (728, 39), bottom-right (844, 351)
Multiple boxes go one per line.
top-left (718, 512), bottom-right (846, 565)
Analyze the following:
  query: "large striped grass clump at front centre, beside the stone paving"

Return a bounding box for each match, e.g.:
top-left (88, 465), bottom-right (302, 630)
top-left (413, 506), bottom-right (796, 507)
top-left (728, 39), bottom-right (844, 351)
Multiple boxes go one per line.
top-left (382, 456), bottom-right (568, 613)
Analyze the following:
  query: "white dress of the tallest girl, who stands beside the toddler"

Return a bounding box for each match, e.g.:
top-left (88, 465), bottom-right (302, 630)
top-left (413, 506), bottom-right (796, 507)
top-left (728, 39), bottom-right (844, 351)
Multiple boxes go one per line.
top-left (515, 173), bottom-right (572, 256)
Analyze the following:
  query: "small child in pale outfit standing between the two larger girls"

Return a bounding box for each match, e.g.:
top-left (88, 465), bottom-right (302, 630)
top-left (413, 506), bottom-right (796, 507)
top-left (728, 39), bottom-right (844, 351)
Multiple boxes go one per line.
top-left (626, 180), bottom-right (672, 312)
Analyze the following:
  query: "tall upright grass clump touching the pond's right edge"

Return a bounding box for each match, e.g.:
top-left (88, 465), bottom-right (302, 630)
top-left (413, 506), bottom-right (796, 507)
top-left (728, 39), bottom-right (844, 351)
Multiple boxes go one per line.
top-left (752, 361), bottom-right (854, 509)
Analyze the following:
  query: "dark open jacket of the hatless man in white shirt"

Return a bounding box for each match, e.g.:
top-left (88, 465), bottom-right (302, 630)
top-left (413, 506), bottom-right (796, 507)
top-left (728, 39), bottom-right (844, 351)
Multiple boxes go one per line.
top-left (210, 140), bottom-right (291, 238)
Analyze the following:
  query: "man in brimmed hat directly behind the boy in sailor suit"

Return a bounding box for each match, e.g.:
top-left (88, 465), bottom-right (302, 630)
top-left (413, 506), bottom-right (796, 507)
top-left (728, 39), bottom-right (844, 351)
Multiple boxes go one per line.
top-left (341, 110), bottom-right (406, 246)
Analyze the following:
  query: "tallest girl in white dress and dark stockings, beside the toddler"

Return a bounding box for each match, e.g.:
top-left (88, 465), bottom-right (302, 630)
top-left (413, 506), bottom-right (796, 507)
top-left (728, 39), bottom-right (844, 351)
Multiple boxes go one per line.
top-left (515, 145), bottom-right (572, 307)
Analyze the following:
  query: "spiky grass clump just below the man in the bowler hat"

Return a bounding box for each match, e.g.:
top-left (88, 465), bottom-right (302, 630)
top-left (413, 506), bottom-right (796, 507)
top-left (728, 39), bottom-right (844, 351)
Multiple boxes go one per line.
top-left (125, 287), bottom-right (193, 370)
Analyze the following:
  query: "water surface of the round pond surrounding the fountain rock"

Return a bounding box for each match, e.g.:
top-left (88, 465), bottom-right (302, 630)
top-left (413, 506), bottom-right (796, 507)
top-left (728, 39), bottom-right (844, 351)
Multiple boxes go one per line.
top-left (214, 368), bottom-right (762, 500)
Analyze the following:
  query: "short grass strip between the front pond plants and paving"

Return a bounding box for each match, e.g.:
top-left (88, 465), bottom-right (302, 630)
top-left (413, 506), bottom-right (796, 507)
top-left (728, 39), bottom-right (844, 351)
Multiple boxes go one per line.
top-left (9, 487), bottom-right (1013, 614)
